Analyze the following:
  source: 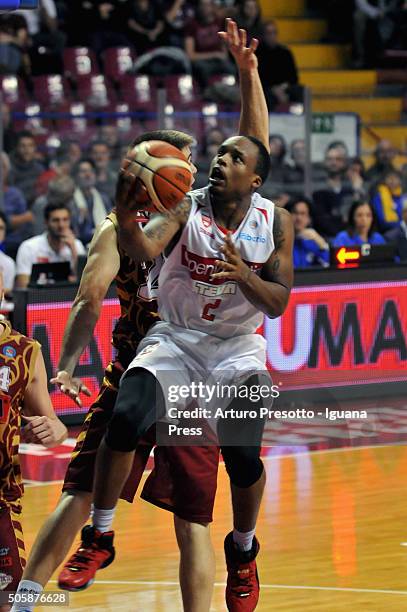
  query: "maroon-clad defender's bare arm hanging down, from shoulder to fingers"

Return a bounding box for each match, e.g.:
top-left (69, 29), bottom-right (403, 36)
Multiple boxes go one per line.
top-left (51, 220), bottom-right (120, 406)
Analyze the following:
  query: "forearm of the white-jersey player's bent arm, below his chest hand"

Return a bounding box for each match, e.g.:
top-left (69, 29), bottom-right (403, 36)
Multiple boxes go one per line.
top-left (239, 272), bottom-right (290, 319)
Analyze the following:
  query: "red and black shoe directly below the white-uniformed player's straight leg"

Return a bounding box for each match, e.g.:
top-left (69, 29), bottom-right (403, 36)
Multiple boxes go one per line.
top-left (225, 532), bottom-right (260, 612)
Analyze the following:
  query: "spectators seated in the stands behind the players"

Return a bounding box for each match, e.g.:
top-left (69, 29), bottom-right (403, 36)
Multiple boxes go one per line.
top-left (0, 0), bottom-right (407, 293)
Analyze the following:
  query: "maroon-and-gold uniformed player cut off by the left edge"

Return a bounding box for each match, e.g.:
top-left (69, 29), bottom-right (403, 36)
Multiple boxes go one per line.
top-left (0, 275), bottom-right (67, 612)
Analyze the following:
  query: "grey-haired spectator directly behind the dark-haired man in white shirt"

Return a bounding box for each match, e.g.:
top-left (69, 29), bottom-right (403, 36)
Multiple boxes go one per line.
top-left (31, 176), bottom-right (79, 236)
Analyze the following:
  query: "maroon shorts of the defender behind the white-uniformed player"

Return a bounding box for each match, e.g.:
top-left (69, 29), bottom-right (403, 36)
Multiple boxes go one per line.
top-left (62, 361), bottom-right (219, 523)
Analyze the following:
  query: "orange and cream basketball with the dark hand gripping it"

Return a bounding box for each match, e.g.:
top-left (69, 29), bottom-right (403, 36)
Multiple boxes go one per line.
top-left (120, 140), bottom-right (193, 212)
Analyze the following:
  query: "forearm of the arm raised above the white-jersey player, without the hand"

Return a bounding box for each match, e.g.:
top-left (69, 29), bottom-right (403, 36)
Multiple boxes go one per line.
top-left (239, 69), bottom-right (269, 150)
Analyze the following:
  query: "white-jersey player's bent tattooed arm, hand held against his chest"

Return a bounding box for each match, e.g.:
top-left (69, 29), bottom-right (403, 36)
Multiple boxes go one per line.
top-left (212, 207), bottom-right (294, 319)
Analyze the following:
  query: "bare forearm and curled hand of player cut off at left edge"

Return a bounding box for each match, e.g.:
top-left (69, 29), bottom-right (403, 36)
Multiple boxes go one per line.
top-left (21, 350), bottom-right (68, 448)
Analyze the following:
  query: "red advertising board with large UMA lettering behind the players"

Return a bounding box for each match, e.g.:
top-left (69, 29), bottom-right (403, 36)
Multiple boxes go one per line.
top-left (26, 281), bottom-right (407, 413)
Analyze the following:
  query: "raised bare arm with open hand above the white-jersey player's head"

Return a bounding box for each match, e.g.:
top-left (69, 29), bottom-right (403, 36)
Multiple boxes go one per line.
top-left (219, 19), bottom-right (270, 151)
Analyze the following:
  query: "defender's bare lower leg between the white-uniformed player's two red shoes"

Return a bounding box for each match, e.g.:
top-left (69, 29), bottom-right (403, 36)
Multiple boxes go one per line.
top-left (174, 515), bottom-right (215, 612)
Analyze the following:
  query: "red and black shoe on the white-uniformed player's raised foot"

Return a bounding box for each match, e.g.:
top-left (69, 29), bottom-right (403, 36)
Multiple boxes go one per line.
top-left (58, 525), bottom-right (115, 591)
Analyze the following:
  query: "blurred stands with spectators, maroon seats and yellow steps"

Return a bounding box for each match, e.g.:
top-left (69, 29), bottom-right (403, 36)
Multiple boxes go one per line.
top-left (0, 0), bottom-right (407, 292)
